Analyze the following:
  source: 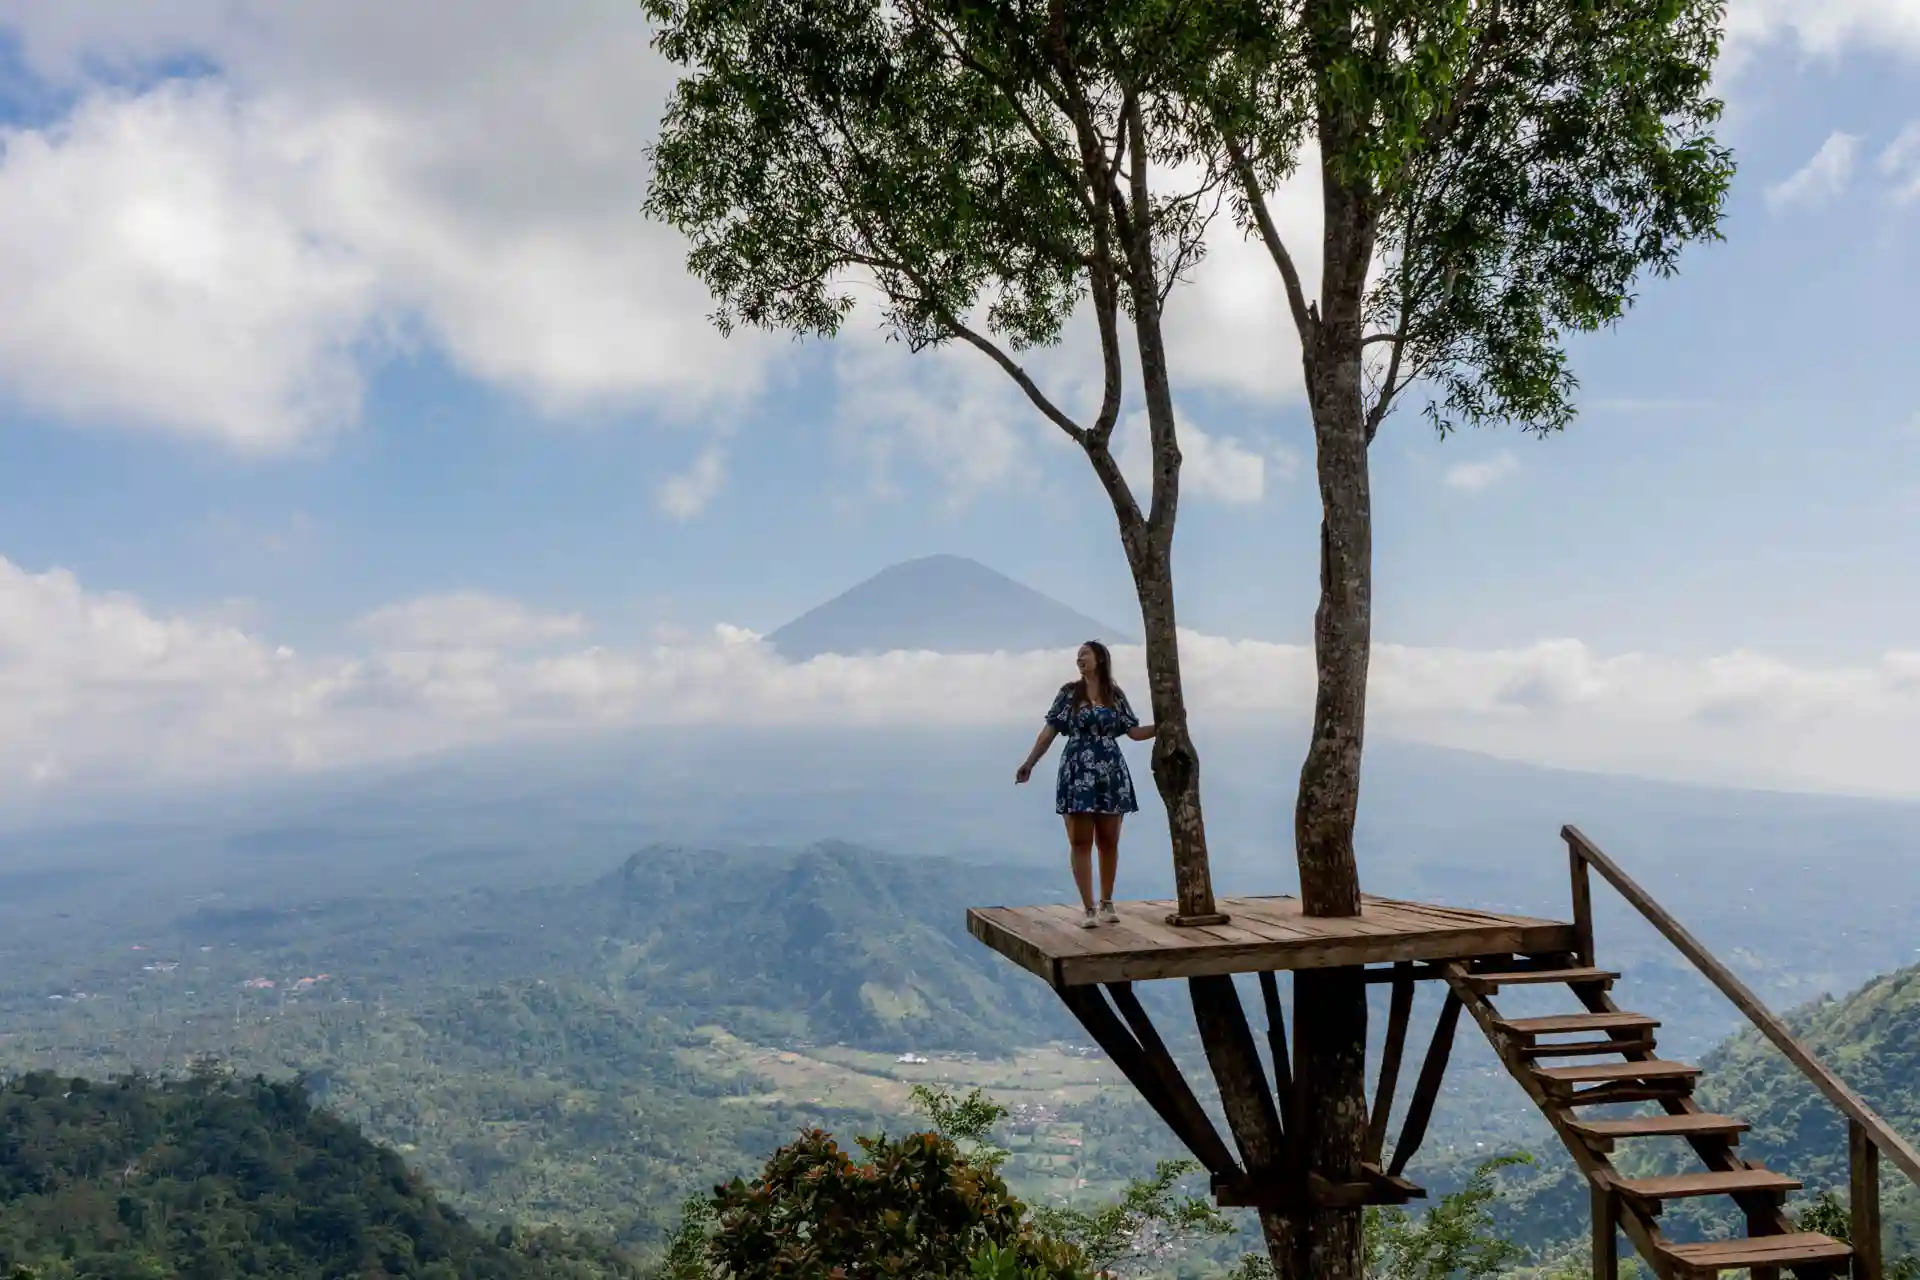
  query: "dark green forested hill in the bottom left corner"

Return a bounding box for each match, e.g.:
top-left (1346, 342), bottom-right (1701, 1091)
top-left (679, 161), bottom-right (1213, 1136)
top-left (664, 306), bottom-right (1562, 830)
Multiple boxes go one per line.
top-left (0, 1071), bottom-right (639, 1280)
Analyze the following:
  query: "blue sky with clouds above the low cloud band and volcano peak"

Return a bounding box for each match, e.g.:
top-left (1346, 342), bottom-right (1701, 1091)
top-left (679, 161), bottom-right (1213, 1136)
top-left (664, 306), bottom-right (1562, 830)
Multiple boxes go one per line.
top-left (0, 0), bottom-right (1920, 791)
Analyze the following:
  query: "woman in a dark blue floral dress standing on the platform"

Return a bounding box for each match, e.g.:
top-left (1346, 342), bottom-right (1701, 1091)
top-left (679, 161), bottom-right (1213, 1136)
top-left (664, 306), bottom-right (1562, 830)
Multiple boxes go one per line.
top-left (1014, 641), bottom-right (1154, 929)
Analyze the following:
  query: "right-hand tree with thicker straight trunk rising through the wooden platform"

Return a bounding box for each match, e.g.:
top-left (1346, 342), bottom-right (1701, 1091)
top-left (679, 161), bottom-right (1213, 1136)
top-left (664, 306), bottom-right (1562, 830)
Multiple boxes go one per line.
top-left (1187, 0), bottom-right (1732, 1280)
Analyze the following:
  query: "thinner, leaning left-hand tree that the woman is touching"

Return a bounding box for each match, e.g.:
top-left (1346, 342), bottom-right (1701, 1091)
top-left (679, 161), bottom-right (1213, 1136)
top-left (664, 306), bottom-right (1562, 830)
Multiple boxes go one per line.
top-left (645, 0), bottom-right (1305, 1274)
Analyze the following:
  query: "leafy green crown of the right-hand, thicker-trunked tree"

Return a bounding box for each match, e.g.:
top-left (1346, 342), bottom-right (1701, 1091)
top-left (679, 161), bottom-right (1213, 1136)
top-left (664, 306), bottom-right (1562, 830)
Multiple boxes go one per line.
top-left (1188, 0), bottom-right (1734, 438)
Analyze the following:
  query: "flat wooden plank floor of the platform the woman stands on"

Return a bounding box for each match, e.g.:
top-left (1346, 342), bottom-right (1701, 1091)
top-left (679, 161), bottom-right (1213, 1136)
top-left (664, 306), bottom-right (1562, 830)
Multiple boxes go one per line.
top-left (966, 896), bottom-right (1574, 986)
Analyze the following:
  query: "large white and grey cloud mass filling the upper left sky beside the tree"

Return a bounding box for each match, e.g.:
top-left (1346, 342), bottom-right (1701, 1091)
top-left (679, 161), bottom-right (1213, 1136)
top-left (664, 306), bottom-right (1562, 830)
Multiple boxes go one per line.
top-left (0, 0), bottom-right (772, 449)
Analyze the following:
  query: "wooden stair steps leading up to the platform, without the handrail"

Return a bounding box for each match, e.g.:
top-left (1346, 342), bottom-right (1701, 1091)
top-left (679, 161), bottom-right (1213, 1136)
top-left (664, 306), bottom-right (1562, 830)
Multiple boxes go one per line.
top-left (1442, 961), bottom-right (1853, 1280)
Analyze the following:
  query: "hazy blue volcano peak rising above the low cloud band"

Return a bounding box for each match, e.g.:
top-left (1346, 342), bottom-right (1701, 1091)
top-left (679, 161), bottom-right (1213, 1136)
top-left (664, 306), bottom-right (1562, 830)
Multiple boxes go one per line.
top-left (766, 555), bottom-right (1135, 662)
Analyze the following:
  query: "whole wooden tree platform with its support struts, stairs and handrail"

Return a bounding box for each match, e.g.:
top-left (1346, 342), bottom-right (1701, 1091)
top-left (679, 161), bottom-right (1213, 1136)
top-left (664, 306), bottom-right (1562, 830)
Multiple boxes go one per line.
top-left (968, 827), bottom-right (1920, 1280)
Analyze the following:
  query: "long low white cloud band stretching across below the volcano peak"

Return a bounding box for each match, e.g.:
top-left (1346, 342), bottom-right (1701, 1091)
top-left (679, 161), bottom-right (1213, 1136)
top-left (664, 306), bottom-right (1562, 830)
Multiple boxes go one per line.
top-left (0, 560), bottom-right (1920, 796)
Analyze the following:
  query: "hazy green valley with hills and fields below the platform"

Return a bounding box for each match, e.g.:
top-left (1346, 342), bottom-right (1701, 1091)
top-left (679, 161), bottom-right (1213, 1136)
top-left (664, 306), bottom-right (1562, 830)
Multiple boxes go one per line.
top-left (0, 844), bottom-right (1920, 1274)
